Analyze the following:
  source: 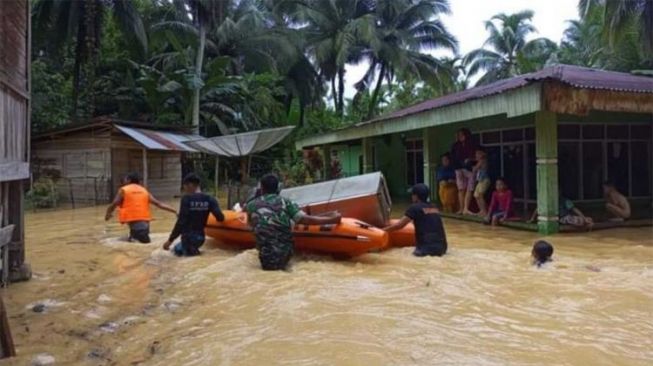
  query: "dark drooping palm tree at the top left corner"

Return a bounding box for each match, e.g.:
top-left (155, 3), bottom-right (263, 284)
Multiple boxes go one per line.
top-left (32, 0), bottom-right (147, 120)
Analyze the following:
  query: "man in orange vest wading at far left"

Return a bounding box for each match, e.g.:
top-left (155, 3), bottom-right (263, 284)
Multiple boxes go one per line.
top-left (104, 173), bottom-right (177, 244)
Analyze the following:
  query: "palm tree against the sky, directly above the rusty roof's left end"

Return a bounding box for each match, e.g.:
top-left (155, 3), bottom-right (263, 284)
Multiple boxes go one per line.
top-left (356, 0), bottom-right (457, 118)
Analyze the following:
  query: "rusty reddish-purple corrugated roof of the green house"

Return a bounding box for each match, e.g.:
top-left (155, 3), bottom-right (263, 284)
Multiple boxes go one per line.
top-left (356, 65), bottom-right (653, 128)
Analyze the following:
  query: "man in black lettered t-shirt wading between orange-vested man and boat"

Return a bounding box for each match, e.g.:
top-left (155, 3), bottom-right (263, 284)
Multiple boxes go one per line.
top-left (163, 173), bottom-right (224, 257)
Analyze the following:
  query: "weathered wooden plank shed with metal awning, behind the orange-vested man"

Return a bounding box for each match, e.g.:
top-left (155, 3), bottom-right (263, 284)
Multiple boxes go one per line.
top-left (32, 118), bottom-right (201, 204)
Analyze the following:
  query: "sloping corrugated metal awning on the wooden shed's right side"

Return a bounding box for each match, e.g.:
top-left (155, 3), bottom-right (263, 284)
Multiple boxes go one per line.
top-left (115, 125), bottom-right (203, 152)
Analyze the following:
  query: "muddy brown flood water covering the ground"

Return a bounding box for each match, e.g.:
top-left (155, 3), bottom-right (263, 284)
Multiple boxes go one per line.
top-left (3, 207), bottom-right (653, 365)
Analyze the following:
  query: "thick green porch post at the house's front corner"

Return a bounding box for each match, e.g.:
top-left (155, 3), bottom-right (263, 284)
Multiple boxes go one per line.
top-left (535, 111), bottom-right (559, 235)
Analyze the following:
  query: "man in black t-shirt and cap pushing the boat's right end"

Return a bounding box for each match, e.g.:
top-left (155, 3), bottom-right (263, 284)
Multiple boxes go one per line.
top-left (384, 183), bottom-right (447, 257)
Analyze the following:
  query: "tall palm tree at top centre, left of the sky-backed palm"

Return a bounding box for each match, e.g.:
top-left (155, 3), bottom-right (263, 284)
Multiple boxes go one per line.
top-left (298, 0), bottom-right (374, 116)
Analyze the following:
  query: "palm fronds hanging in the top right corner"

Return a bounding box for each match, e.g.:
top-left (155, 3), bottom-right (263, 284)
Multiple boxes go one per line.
top-left (578, 0), bottom-right (653, 57)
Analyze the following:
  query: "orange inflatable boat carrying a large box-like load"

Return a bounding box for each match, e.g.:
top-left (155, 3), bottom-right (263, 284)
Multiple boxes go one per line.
top-left (205, 210), bottom-right (388, 257)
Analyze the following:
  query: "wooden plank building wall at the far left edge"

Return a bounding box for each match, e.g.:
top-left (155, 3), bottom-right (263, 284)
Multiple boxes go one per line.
top-left (0, 0), bottom-right (30, 280)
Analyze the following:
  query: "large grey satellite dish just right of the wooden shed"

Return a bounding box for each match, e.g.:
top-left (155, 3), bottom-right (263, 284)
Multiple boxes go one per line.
top-left (185, 126), bottom-right (295, 157)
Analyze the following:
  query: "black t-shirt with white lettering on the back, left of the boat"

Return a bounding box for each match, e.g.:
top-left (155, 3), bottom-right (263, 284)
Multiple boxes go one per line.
top-left (170, 192), bottom-right (224, 241)
